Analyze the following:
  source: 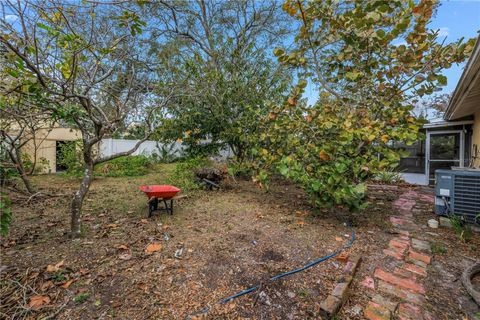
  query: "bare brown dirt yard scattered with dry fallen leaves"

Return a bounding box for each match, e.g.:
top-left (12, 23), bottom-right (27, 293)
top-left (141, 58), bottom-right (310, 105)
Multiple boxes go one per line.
top-left (0, 165), bottom-right (480, 319)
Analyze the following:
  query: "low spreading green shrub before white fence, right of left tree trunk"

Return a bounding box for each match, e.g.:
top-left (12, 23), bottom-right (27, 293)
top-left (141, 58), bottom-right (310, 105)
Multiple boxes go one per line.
top-left (95, 155), bottom-right (152, 177)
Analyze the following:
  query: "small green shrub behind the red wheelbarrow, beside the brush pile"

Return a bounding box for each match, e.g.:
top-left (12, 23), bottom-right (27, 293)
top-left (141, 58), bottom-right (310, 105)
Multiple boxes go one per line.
top-left (167, 158), bottom-right (211, 190)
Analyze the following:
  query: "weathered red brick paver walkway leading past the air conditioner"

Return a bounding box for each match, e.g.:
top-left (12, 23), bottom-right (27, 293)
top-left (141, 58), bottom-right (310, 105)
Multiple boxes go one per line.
top-left (362, 191), bottom-right (433, 320)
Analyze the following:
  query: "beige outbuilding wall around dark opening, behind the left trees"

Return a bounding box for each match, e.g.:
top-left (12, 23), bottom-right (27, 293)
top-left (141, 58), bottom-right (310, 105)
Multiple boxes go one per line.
top-left (23, 128), bottom-right (82, 173)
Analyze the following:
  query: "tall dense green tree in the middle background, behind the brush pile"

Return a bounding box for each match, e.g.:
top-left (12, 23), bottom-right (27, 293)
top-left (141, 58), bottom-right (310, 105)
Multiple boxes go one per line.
top-left (152, 1), bottom-right (291, 161)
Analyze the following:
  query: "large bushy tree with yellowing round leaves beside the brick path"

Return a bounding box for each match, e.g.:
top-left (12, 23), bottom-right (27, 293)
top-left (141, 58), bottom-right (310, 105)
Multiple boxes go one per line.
top-left (254, 1), bottom-right (474, 209)
